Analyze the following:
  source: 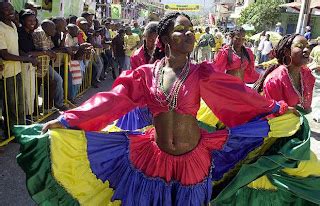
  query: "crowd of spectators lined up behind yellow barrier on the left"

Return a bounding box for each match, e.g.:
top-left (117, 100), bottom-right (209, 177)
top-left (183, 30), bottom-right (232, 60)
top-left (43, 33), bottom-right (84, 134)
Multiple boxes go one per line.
top-left (0, 2), bottom-right (143, 139)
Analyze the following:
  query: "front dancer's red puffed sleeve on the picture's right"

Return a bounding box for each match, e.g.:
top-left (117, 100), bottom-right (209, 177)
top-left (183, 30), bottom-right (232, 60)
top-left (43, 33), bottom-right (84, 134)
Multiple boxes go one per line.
top-left (199, 63), bottom-right (280, 127)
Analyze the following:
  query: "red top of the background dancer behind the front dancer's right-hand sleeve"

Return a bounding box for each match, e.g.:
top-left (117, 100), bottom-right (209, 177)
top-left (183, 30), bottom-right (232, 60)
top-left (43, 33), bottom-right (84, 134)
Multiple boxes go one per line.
top-left (214, 46), bottom-right (260, 83)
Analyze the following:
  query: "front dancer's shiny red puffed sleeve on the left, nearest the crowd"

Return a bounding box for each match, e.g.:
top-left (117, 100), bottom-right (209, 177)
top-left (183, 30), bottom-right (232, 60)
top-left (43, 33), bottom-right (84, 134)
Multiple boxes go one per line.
top-left (58, 70), bottom-right (145, 131)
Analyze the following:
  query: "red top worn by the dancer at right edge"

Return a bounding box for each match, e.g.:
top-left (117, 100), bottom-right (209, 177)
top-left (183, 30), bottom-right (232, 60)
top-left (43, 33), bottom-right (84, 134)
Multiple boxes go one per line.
top-left (263, 65), bottom-right (315, 110)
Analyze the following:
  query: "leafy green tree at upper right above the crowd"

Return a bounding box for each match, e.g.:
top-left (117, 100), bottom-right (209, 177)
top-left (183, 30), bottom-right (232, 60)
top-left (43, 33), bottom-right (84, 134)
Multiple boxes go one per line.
top-left (238, 0), bottom-right (284, 32)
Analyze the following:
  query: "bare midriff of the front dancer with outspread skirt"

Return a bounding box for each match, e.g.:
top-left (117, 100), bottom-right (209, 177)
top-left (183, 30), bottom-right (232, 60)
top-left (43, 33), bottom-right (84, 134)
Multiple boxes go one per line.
top-left (154, 111), bottom-right (200, 155)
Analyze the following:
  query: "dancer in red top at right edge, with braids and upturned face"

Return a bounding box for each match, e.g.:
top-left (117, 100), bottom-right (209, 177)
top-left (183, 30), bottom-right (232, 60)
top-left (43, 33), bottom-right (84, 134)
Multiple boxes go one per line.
top-left (258, 34), bottom-right (315, 113)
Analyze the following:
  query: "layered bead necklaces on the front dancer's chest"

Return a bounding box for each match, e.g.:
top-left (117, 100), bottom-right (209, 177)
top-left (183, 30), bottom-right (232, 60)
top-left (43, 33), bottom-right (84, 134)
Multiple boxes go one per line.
top-left (155, 58), bottom-right (190, 111)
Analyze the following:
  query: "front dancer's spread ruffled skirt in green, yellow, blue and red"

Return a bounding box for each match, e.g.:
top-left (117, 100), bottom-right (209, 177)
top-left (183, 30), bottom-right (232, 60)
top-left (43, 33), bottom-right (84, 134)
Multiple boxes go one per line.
top-left (16, 114), bottom-right (320, 206)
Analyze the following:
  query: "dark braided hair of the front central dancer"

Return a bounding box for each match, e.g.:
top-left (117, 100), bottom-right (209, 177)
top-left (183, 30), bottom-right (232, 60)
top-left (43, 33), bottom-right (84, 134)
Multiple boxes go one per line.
top-left (151, 12), bottom-right (191, 62)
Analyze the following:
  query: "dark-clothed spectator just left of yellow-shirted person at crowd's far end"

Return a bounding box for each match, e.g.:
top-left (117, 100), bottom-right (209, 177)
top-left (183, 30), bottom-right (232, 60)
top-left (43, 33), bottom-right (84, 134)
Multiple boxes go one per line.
top-left (111, 29), bottom-right (125, 74)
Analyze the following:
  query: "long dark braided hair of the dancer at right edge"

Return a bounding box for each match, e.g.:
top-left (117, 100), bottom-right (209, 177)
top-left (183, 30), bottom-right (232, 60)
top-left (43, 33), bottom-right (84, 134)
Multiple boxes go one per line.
top-left (254, 34), bottom-right (300, 93)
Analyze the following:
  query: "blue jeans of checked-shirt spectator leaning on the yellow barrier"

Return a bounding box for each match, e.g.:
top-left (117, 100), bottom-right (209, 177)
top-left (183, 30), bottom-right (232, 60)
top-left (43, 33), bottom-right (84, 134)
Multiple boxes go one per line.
top-left (49, 67), bottom-right (64, 108)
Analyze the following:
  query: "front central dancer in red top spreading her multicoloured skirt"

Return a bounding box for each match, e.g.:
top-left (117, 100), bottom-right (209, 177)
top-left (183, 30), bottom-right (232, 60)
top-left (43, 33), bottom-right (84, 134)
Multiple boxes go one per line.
top-left (16, 13), bottom-right (320, 206)
